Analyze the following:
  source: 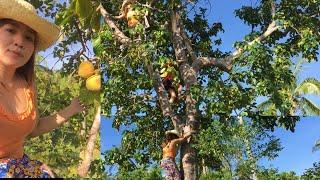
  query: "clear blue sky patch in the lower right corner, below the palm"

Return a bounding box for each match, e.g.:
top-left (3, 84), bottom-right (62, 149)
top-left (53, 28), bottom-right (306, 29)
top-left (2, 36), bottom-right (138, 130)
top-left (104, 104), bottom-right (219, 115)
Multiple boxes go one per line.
top-left (259, 116), bottom-right (320, 175)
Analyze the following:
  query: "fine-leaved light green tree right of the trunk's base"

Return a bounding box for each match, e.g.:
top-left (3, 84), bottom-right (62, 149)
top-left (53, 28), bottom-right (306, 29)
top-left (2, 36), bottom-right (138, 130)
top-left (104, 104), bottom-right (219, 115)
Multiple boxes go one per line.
top-left (194, 117), bottom-right (282, 179)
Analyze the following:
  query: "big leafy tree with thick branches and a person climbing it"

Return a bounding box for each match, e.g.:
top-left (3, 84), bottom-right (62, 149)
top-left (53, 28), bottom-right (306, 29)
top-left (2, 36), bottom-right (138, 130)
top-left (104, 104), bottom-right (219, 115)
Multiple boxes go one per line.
top-left (99, 0), bottom-right (320, 179)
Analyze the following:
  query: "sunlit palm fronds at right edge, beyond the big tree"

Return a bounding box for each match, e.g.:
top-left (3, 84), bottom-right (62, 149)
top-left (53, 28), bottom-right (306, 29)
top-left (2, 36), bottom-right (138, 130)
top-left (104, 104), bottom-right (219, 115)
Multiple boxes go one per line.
top-left (258, 59), bottom-right (320, 116)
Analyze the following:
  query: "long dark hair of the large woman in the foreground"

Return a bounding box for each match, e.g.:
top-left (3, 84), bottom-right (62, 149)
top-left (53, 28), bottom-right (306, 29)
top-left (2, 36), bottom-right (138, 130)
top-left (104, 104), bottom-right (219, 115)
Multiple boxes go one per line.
top-left (0, 19), bottom-right (38, 86)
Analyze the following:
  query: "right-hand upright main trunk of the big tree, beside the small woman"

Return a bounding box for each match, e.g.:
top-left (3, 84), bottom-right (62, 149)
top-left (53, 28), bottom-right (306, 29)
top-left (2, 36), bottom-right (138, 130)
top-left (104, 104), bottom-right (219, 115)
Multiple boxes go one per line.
top-left (171, 8), bottom-right (197, 180)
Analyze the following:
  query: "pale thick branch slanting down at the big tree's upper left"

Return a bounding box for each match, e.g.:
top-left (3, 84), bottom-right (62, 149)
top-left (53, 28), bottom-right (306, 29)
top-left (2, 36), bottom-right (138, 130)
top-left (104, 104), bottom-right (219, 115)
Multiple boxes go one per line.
top-left (97, 4), bottom-right (131, 45)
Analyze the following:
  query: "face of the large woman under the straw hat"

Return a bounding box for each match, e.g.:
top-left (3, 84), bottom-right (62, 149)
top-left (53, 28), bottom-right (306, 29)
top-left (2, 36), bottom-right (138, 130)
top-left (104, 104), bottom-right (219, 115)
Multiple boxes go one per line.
top-left (0, 20), bottom-right (36, 68)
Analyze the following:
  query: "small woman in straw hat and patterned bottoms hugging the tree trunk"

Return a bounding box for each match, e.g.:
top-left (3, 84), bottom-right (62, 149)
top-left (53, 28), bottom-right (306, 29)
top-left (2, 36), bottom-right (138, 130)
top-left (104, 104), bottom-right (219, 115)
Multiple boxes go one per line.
top-left (160, 130), bottom-right (191, 180)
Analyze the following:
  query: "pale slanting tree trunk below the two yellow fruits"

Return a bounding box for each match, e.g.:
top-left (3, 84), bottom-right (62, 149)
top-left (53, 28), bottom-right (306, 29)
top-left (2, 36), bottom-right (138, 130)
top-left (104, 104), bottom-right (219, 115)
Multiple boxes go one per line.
top-left (78, 106), bottom-right (101, 177)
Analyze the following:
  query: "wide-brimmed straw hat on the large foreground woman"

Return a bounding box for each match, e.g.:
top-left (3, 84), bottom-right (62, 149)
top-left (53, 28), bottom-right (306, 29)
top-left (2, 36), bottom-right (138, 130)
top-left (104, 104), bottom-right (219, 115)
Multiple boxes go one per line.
top-left (0, 0), bottom-right (60, 51)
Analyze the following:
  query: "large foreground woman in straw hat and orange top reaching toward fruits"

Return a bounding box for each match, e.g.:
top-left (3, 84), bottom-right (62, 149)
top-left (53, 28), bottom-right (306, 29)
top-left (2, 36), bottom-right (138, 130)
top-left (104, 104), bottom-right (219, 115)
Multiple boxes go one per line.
top-left (0, 0), bottom-right (85, 178)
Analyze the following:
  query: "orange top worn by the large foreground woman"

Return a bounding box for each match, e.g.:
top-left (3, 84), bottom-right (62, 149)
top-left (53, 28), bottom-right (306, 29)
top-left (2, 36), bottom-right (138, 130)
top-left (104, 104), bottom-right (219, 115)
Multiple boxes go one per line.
top-left (0, 88), bottom-right (36, 159)
